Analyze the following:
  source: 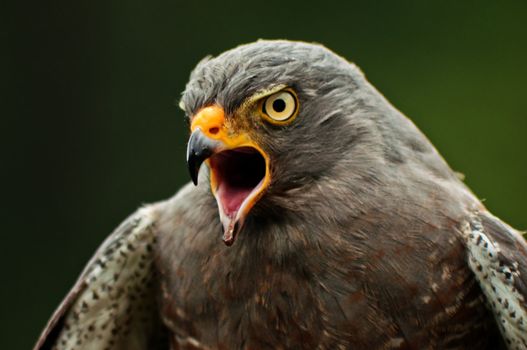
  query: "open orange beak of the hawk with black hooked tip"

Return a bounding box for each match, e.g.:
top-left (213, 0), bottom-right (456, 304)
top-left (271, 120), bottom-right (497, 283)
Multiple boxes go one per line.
top-left (187, 105), bottom-right (270, 246)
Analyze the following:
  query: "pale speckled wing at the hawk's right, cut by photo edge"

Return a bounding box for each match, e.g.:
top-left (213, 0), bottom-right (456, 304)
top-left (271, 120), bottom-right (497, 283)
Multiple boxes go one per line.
top-left (464, 212), bottom-right (527, 349)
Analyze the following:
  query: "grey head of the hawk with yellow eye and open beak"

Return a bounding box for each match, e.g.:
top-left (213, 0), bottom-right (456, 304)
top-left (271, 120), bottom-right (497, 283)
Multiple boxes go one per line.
top-left (180, 41), bottom-right (454, 245)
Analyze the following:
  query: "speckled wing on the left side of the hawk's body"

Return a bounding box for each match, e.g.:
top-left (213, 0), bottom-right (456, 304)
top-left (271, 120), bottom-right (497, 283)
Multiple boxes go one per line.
top-left (34, 207), bottom-right (168, 350)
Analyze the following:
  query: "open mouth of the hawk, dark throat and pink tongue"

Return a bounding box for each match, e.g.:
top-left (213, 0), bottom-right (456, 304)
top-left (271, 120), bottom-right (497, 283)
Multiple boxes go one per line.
top-left (209, 147), bottom-right (266, 219)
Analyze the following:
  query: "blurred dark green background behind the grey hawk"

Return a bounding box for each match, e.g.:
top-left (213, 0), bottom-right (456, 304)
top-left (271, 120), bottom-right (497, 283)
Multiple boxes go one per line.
top-left (0, 0), bottom-right (527, 349)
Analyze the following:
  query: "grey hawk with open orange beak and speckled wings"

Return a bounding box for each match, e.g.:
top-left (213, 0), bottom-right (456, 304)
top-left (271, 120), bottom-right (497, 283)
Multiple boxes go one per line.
top-left (35, 40), bottom-right (527, 350)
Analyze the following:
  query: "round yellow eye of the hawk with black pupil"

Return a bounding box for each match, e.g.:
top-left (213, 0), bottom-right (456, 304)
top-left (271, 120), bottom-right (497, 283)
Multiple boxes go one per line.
top-left (262, 90), bottom-right (298, 124)
